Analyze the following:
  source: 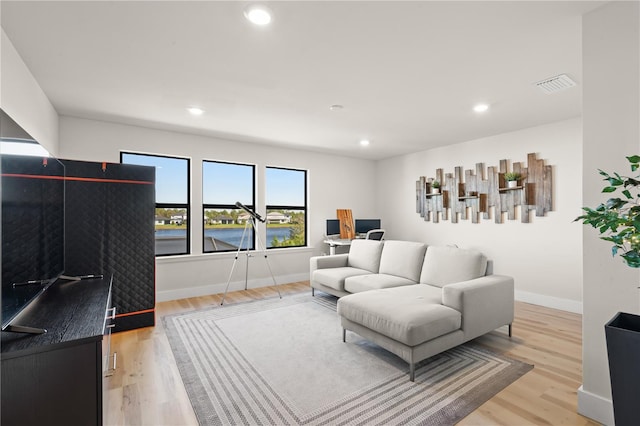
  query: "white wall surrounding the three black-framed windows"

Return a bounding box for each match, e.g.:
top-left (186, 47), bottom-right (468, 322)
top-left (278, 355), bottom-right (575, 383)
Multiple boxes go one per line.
top-left (59, 116), bottom-right (378, 301)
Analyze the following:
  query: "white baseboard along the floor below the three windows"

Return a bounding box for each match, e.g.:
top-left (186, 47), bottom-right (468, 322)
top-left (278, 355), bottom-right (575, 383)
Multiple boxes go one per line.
top-left (156, 272), bottom-right (309, 302)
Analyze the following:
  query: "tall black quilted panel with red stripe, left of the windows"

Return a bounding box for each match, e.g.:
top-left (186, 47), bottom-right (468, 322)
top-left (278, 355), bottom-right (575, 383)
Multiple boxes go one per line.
top-left (62, 160), bottom-right (155, 330)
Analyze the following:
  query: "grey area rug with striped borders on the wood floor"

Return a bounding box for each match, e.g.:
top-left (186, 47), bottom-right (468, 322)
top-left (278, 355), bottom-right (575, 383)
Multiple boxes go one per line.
top-left (163, 295), bottom-right (533, 425)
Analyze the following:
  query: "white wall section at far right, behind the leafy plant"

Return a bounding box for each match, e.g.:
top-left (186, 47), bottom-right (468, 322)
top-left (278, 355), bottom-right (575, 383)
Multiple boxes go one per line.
top-left (578, 2), bottom-right (640, 424)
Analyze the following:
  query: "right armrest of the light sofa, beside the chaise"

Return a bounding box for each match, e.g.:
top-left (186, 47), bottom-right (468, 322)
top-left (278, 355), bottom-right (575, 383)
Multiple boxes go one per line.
top-left (442, 275), bottom-right (514, 340)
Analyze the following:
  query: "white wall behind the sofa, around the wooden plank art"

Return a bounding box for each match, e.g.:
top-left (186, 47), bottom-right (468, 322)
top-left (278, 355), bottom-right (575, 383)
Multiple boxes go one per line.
top-left (376, 116), bottom-right (582, 312)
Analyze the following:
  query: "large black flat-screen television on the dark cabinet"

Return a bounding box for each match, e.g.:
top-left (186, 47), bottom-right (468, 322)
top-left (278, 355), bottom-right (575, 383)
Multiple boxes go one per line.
top-left (0, 154), bottom-right (65, 331)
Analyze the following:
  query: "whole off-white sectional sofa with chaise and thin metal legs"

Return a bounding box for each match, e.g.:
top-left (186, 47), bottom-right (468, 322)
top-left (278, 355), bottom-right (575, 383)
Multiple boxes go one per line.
top-left (310, 240), bottom-right (514, 381)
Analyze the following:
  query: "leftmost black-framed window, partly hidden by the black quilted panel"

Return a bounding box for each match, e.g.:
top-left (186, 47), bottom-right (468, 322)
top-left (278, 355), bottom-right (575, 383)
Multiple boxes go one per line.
top-left (120, 152), bottom-right (190, 256)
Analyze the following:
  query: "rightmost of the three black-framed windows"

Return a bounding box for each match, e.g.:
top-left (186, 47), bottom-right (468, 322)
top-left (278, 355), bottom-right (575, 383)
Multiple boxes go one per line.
top-left (265, 167), bottom-right (307, 248)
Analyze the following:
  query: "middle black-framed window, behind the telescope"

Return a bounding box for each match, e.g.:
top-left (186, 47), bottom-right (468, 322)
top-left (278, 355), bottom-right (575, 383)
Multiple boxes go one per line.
top-left (202, 161), bottom-right (255, 253)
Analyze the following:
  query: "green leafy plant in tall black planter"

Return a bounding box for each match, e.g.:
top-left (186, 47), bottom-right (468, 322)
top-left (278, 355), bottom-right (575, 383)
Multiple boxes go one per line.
top-left (575, 155), bottom-right (640, 426)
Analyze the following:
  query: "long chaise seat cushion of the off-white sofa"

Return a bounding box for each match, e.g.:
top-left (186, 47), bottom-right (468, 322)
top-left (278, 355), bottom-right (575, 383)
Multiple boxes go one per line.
top-left (338, 284), bottom-right (462, 346)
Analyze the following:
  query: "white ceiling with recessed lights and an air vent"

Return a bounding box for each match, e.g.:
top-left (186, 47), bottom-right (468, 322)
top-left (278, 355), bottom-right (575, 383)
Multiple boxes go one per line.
top-left (0, 0), bottom-right (604, 159)
